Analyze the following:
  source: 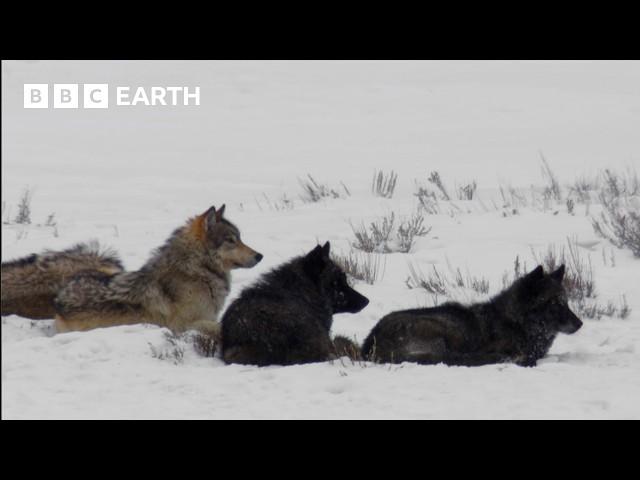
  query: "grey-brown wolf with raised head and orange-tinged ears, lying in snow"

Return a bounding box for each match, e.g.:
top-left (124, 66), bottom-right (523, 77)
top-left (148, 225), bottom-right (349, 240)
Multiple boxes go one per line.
top-left (55, 205), bottom-right (262, 335)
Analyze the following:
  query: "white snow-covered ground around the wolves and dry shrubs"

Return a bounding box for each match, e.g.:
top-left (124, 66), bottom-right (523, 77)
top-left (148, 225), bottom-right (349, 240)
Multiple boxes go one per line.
top-left (2, 62), bottom-right (640, 418)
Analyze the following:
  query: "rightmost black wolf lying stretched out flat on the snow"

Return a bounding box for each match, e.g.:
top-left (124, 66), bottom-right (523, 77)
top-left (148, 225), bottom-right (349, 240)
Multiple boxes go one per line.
top-left (362, 265), bottom-right (582, 367)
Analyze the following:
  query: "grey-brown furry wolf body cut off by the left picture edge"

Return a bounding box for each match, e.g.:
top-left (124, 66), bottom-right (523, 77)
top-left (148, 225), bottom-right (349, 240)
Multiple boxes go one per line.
top-left (2, 242), bottom-right (123, 319)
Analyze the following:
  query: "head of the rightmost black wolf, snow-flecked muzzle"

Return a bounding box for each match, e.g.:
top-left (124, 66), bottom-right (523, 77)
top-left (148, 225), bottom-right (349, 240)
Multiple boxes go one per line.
top-left (508, 265), bottom-right (582, 334)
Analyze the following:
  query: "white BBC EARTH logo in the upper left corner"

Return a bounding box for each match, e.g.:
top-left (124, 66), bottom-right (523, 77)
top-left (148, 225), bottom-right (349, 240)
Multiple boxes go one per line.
top-left (24, 83), bottom-right (200, 109)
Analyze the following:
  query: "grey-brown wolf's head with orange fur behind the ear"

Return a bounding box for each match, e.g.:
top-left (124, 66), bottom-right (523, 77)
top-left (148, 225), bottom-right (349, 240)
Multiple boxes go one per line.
top-left (196, 205), bottom-right (262, 270)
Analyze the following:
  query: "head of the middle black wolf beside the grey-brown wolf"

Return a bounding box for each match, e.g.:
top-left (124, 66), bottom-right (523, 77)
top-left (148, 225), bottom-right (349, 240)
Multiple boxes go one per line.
top-left (303, 242), bottom-right (369, 313)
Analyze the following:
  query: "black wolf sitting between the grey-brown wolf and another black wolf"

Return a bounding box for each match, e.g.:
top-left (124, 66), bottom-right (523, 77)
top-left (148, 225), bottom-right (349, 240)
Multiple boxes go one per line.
top-left (222, 242), bottom-right (369, 365)
